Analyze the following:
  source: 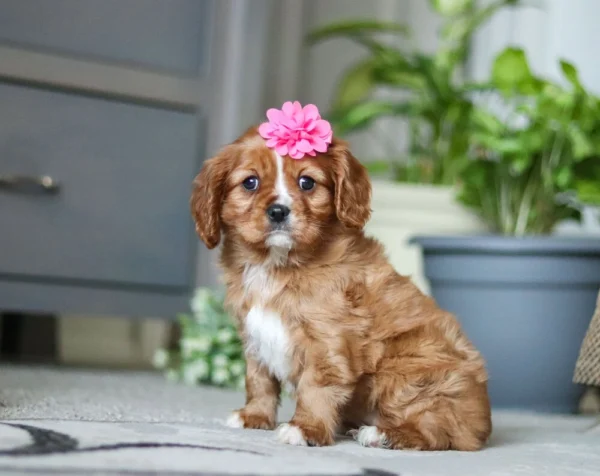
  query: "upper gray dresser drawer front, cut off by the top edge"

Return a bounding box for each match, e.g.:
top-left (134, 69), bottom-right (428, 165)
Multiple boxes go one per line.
top-left (0, 0), bottom-right (213, 75)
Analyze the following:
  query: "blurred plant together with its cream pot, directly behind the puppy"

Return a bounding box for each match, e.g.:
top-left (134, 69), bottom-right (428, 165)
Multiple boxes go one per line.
top-left (308, 0), bottom-right (517, 291)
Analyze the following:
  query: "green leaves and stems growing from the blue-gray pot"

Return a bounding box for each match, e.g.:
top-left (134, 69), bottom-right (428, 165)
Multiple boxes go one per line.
top-left (459, 48), bottom-right (600, 236)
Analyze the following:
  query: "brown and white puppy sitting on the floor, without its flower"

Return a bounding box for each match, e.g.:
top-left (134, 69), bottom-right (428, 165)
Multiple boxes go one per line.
top-left (191, 128), bottom-right (491, 451)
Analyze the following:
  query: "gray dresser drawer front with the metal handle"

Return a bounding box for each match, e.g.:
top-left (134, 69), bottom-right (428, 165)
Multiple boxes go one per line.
top-left (0, 83), bottom-right (201, 287)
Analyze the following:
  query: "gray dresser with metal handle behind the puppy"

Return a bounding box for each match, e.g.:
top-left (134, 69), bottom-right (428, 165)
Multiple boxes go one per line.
top-left (0, 0), bottom-right (215, 317)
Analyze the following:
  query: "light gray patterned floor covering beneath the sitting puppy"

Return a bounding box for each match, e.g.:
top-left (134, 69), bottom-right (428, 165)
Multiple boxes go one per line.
top-left (0, 366), bottom-right (600, 476)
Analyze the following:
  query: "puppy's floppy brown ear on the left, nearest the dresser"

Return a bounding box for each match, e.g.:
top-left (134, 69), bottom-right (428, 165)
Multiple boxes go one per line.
top-left (190, 145), bottom-right (235, 249)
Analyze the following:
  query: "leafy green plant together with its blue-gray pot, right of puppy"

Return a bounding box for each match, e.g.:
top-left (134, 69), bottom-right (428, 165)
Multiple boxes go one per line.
top-left (414, 48), bottom-right (600, 412)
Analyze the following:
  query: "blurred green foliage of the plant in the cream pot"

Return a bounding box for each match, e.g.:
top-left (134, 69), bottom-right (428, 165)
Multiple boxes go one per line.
top-left (308, 0), bottom-right (518, 184)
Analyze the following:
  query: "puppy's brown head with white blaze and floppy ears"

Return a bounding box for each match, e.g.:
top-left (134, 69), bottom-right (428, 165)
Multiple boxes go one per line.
top-left (191, 124), bottom-right (371, 255)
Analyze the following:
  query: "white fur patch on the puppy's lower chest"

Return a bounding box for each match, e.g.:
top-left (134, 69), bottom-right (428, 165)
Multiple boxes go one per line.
top-left (246, 306), bottom-right (290, 382)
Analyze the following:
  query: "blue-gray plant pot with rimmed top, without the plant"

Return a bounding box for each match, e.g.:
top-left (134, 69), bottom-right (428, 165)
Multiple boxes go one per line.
top-left (411, 236), bottom-right (600, 413)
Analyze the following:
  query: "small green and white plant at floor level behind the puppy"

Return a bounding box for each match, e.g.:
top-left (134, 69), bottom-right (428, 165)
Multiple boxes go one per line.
top-left (154, 288), bottom-right (246, 389)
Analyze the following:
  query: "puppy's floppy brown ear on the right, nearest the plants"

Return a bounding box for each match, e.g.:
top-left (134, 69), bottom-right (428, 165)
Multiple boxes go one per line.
top-left (331, 139), bottom-right (371, 229)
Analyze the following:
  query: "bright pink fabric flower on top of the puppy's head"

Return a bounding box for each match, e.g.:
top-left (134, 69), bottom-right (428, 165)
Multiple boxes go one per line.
top-left (258, 101), bottom-right (333, 159)
